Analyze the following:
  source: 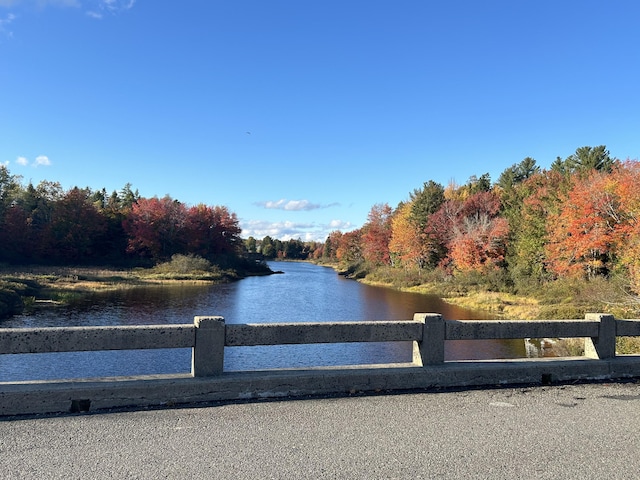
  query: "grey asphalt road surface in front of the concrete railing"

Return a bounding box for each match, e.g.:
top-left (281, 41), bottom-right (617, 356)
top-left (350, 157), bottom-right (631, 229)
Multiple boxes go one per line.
top-left (0, 383), bottom-right (640, 480)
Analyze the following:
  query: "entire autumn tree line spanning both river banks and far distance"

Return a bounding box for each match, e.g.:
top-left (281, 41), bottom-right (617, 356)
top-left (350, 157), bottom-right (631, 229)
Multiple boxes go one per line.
top-left (0, 145), bottom-right (640, 295)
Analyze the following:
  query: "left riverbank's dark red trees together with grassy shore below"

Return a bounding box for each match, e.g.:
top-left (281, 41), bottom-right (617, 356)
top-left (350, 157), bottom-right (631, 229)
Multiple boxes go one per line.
top-left (0, 165), bottom-right (272, 318)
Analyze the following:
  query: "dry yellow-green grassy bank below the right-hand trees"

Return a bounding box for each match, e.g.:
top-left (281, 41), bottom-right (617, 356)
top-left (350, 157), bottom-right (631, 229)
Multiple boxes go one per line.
top-left (324, 265), bottom-right (640, 355)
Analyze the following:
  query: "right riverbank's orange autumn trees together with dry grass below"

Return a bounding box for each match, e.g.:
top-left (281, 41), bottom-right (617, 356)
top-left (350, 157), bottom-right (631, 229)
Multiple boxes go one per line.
top-left (319, 146), bottom-right (640, 326)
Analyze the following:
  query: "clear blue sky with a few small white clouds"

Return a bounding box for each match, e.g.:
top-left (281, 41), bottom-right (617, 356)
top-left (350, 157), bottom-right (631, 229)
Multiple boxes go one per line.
top-left (0, 0), bottom-right (640, 244)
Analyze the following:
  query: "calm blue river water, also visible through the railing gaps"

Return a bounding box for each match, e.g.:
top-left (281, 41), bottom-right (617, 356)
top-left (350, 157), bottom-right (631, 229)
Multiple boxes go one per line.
top-left (0, 262), bottom-right (525, 381)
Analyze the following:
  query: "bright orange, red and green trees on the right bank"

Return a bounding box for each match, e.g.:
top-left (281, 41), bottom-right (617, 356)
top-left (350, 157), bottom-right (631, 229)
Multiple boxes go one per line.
top-left (322, 145), bottom-right (640, 294)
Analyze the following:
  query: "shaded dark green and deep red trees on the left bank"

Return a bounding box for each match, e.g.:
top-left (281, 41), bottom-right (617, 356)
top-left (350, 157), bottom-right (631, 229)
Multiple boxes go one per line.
top-left (0, 165), bottom-right (243, 265)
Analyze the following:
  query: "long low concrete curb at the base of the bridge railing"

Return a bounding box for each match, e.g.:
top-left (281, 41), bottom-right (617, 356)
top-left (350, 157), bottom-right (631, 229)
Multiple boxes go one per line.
top-left (0, 357), bottom-right (640, 416)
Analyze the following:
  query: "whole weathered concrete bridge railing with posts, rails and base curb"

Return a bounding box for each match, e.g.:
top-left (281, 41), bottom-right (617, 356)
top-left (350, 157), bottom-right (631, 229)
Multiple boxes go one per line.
top-left (0, 313), bottom-right (640, 415)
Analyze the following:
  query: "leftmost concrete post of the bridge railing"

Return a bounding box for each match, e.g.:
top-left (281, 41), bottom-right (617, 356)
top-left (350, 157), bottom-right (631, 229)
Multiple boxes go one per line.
top-left (191, 317), bottom-right (225, 377)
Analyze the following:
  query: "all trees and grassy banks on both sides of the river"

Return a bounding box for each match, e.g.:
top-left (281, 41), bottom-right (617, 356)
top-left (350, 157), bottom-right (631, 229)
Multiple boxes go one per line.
top-left (0, 146), bottom-right (640, 328)
